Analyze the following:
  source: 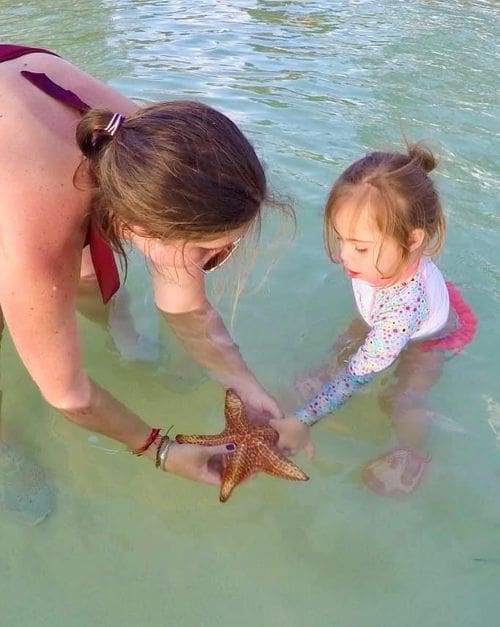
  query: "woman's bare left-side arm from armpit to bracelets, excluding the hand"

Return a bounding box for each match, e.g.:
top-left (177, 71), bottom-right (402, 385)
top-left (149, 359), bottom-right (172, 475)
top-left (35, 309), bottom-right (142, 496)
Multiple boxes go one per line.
top-left (0, 228), bottom-right (154, 448)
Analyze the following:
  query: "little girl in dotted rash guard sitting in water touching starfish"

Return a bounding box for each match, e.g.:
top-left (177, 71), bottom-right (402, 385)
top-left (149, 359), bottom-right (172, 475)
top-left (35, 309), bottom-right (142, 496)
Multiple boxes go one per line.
top-left (271, 145), bottom-right (476, 496)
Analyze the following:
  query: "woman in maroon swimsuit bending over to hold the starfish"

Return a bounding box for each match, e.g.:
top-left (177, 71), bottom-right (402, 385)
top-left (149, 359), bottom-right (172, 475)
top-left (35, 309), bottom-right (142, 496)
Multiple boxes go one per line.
top-left (0, 45), bottom-right (281, 484)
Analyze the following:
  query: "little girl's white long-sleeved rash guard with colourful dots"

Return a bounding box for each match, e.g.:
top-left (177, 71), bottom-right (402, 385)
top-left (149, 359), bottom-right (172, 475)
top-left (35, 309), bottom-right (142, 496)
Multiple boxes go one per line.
top-left (295, 259), bottom-right (449, 425)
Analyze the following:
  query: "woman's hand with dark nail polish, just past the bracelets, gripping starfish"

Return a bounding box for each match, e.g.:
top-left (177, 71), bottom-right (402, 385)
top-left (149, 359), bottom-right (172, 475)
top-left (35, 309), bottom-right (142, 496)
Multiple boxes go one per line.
top-left (164, 442), bottom-right (236, 486)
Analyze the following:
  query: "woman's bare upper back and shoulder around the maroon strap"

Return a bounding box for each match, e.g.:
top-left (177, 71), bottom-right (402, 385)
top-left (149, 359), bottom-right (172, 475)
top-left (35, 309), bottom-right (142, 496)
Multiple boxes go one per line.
top-left (0, 53), bottom-right (136, 262)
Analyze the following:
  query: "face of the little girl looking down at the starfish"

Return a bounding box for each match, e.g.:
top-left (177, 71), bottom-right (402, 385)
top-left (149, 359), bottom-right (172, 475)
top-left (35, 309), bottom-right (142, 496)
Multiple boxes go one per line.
top-left (333, 199), bottom-right (402, 287)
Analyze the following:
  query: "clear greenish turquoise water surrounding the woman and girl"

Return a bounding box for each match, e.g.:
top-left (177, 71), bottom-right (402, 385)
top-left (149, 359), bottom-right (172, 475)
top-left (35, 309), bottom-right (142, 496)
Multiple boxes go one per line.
top-left (0, 0), bottom-right (500, 627)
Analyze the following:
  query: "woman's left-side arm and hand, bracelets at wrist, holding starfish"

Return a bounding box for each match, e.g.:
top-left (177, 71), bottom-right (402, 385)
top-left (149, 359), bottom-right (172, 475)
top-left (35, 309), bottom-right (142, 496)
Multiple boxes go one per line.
top-left (0, 243), bottom-right (234, 485)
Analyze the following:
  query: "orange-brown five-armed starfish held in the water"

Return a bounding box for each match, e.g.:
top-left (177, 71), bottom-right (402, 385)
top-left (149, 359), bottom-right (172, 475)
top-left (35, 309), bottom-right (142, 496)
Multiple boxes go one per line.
top-left (175, 390), bottom-right (309, 503)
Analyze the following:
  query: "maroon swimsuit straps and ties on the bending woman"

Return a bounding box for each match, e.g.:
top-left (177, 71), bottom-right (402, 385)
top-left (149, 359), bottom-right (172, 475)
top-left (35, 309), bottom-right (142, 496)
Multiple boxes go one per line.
top-left (0, 44), bottom-right (120, 303)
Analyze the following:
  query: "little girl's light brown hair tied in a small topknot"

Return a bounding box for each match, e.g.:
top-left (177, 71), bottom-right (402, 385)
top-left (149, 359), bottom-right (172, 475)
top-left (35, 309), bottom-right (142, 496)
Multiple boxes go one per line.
top-left (324, 143), bottom-right (445, 274)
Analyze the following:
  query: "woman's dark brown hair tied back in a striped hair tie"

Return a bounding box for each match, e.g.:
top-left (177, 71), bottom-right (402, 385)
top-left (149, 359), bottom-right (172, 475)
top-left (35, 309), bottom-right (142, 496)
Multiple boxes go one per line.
top-left (76, 101), bottom-right (274, 254)
